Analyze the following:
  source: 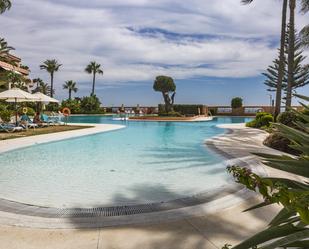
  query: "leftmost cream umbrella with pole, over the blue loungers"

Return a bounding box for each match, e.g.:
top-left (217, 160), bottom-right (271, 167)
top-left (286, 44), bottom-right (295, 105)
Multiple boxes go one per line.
top-left (0, 88), bottom-right (38, 125)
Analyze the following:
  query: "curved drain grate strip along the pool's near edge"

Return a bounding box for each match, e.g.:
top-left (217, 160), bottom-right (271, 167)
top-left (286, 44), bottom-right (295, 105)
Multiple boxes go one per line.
top-left (0, 185), bottom-right (240, 218)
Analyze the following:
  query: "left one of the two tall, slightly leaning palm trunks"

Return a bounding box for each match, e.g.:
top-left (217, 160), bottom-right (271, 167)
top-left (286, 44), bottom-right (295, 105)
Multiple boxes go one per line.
top-left (274, 0), bottom-right (288, 118)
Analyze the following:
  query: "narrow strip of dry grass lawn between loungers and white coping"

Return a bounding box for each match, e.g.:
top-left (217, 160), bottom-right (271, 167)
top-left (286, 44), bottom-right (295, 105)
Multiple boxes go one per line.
top-left (0, 125), bottom-right (92, 140)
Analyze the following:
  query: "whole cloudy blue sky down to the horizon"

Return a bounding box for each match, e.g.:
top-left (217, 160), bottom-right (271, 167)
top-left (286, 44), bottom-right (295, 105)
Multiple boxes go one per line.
top-left (0, 0), bottom-right (309, 106)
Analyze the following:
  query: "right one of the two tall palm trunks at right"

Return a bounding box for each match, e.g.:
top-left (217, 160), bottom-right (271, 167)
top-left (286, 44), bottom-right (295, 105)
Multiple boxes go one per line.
top-left (285, 0), bottom-right (295, 110)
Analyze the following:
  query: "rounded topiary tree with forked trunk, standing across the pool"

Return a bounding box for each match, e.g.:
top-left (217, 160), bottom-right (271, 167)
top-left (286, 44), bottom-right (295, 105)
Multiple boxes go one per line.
top-left (153, 75), bottom-right (176, 113)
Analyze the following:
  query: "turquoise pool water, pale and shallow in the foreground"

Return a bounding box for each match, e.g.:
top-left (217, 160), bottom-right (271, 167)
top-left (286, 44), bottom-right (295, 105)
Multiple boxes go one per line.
top-left (0, 116), bottom-right (248, 207)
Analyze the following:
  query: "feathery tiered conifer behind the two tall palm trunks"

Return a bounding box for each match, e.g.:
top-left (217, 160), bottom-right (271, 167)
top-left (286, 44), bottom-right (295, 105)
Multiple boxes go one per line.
top-left (263, 28), bottom-right (309, 102)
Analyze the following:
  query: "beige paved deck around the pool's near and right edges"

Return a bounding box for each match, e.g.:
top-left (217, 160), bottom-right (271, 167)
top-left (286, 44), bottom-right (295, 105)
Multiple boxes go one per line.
top-left (0, 125), bottom-right (286, 249)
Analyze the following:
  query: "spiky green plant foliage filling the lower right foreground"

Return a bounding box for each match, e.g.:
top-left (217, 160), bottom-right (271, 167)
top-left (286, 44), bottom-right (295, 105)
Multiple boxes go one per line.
top-left (226, 95), bottom-right (309, 249)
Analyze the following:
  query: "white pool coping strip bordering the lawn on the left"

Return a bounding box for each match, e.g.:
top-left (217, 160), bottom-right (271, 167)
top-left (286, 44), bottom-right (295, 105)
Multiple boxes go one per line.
top-left (0, 123), bottom-right (125, 153)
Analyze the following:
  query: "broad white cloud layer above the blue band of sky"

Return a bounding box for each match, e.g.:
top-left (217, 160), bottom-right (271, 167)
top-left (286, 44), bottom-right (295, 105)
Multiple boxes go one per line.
top-left (0, 0), bottom-right (306, 99)
